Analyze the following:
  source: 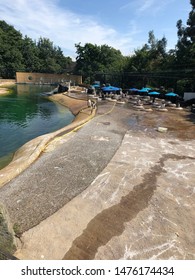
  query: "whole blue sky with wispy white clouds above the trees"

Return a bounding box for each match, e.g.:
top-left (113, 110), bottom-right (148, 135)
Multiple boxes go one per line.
top-left (0, 0), bottom-right (191, 58)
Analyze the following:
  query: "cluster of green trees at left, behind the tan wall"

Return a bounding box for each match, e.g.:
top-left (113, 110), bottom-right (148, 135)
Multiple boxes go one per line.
top-left (0, 21), bottom-right (72, 78)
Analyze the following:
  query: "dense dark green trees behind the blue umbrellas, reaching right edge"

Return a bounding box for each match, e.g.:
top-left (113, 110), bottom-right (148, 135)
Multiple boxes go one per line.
top-left (75, 0), bottom-right (195, 91)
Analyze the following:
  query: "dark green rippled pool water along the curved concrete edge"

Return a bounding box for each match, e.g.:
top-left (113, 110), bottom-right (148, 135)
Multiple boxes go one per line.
top-left (0, 85), bottom-right (74, 169)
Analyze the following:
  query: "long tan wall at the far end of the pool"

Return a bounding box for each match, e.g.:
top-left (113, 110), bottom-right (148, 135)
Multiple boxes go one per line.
top-left (16, 72), bottom-right (82, 85)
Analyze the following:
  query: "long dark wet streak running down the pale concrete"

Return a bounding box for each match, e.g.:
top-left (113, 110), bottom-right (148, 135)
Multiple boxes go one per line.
top-left (63, 154), bottom-right (195, 260)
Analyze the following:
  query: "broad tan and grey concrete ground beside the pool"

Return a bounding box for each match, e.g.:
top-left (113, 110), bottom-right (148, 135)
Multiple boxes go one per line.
top-left (0, 94), bottom-right (195, 260)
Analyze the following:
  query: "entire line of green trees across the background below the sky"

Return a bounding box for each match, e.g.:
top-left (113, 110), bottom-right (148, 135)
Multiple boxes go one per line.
top-left (0, 0), bottom-right (195, 90)
